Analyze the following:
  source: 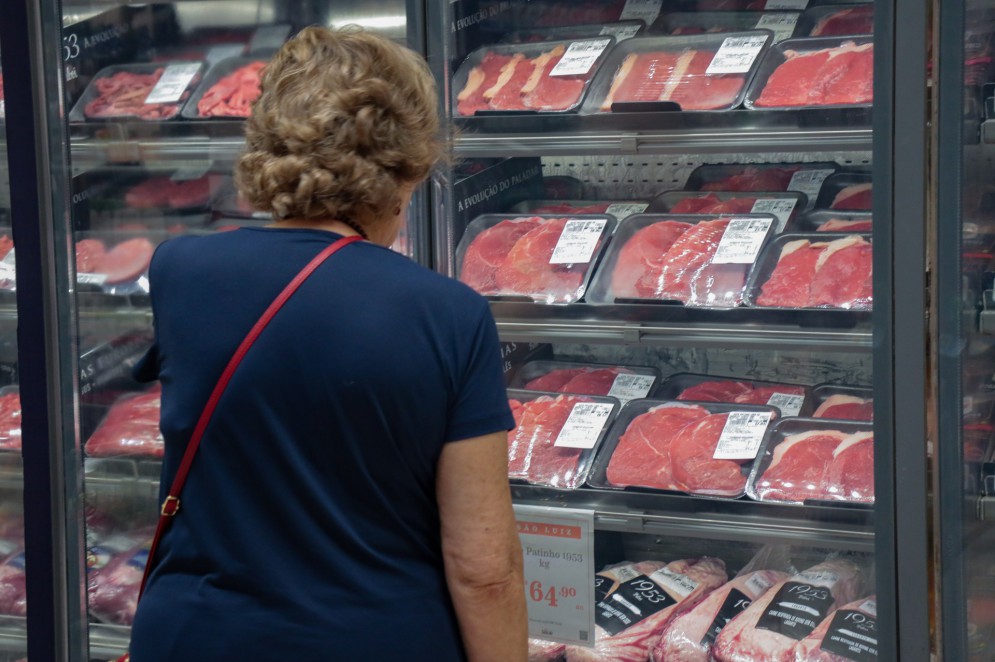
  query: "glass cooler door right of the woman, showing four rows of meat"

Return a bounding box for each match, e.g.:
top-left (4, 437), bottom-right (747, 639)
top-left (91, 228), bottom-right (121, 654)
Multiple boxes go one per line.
top-left (429, 0), bottom-right (929, 660)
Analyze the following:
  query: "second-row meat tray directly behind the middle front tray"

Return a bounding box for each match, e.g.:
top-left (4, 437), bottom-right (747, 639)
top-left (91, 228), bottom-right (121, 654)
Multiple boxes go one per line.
top-left (646, 191), bottom-right (808, 232)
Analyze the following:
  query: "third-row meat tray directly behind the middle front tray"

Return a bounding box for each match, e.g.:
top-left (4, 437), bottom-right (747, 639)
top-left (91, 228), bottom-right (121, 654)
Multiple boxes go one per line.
top-left (653, 372), bottom-right (816, 416)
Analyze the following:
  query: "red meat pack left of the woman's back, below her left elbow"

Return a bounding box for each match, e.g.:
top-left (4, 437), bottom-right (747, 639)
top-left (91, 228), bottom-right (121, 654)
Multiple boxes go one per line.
top-left (83, 384), bottom-right (164, 457)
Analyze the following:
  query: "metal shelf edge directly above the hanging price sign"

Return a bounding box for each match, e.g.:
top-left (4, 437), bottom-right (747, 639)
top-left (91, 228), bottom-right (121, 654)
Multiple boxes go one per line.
top-left (511, 485), bottom-right (874, 551)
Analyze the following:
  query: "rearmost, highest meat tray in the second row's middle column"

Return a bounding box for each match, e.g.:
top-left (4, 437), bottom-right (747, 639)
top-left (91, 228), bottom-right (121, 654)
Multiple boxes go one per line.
top-left (684, 163), bottom-right (839, 207)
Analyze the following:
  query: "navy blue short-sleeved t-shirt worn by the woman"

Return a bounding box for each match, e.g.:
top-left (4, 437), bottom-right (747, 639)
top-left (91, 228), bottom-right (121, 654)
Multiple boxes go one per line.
top-left (131, 228), bottom-right (514, 662)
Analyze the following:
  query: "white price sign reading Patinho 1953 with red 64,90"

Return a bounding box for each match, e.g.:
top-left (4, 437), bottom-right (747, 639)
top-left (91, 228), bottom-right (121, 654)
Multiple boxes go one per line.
top-left (515, 505), bottom-right (594, 647)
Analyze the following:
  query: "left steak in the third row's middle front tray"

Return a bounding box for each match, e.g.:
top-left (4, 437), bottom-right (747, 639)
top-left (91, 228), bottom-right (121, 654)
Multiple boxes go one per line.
top-left (606, 405), bottom-right (709, 491)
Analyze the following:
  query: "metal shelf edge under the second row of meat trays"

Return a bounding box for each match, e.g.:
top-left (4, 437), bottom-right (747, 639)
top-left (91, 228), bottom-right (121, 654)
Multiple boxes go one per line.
top-left (491, 301), bottom-right (872, 352)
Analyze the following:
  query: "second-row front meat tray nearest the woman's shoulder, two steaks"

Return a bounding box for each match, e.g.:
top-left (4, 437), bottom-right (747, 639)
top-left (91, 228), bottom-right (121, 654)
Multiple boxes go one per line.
top-left (456, 214), bottom-right (615, 303)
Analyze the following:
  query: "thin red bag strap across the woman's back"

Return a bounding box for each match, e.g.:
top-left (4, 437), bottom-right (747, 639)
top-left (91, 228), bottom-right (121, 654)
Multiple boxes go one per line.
top-left (118, 236), bottom-right (362, 662)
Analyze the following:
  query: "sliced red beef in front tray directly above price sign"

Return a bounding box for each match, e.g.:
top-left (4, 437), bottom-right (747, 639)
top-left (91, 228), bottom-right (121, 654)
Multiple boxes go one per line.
top-left (508, 395), bottom-right (591, 487)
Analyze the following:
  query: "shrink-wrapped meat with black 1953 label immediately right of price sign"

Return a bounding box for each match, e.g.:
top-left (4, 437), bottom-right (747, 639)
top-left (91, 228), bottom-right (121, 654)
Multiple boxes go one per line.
top-left (567, 557), bottom-right (728, 662)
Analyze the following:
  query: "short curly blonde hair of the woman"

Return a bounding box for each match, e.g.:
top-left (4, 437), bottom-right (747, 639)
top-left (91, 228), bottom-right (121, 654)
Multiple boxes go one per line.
top-left (235, 27), bottom-right (442, 229)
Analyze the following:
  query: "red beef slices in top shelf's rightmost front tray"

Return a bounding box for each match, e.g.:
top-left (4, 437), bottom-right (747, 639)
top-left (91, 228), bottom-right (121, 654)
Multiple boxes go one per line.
top-left (754, 41), bottom-right (874, 108)
